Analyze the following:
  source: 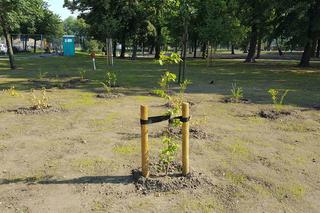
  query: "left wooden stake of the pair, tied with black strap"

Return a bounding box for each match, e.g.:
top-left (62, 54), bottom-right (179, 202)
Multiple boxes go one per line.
top-left (140, 106), bottom-right (149, 177)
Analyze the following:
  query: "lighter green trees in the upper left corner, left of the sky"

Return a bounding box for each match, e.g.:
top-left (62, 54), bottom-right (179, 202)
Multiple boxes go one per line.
top-left (0, 0), bottom-right (64, 69)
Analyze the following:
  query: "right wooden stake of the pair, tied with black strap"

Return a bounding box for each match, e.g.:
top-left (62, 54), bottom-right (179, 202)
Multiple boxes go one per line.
top-left (182, 103), bottom-right (190, 175)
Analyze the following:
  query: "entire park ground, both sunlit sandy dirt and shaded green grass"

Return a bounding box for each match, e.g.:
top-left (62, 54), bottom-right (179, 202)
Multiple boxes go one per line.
top-left (0, 54), bottom-right (320, 212)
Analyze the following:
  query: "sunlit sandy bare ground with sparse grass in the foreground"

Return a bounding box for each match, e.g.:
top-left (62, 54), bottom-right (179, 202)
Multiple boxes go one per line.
top-left (0, 89), bottom-right (320, 212)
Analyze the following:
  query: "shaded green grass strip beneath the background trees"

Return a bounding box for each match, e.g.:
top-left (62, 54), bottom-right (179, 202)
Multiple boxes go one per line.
top-left (0, 54), bottom-right (320, 107)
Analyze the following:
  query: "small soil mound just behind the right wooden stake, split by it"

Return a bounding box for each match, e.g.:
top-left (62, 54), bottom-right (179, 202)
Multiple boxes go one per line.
top-left (154, 126), bottom-right (209, 139)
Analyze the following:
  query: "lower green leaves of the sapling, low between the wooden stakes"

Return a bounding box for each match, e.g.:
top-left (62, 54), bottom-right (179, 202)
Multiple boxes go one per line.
top-left (160, 137), bottom-right (179, 175)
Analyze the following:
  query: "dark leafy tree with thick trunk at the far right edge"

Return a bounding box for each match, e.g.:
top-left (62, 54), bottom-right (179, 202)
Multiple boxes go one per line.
top-left (274, 0), bottom-right (320, 66)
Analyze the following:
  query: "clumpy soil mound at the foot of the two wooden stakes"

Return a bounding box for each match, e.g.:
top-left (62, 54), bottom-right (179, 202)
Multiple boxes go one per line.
top-left (132, 162), bottom-right (212, 194)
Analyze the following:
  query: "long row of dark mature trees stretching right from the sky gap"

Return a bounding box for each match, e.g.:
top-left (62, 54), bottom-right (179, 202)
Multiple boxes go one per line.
top-left (65, 0), bottom-right (320, 66)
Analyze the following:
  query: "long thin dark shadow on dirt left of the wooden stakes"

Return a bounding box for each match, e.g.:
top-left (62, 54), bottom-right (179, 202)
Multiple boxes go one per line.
top-left (0, 175), bottom-right (133, 185)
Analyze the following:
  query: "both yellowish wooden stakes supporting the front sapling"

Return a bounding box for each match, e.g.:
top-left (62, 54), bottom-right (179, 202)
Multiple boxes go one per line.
top-left (140, 103), bottom-right (190, 177)
